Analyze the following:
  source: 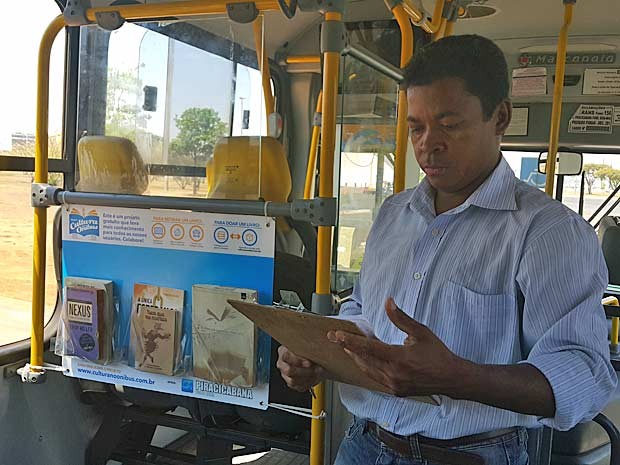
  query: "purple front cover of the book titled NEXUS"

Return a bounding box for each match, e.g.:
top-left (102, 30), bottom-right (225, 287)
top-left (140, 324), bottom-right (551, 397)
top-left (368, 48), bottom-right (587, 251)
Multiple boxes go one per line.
top-left (65, 287), bottom-right (105, 361)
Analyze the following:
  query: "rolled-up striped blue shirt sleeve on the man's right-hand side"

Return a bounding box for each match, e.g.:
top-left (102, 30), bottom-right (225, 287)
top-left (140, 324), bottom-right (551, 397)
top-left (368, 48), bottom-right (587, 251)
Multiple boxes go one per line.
top-left (517, 216), bottom-right (617, 431)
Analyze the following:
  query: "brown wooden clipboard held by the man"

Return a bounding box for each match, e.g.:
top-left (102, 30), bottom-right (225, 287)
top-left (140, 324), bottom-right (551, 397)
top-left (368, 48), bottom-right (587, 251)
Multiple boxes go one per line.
top-left (228, 300), bottom-right (439, 405)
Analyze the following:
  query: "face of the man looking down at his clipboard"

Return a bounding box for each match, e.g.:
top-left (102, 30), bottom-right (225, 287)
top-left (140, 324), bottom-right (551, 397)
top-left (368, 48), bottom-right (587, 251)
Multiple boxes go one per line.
top-left (407, 78), bottom-right (510, 194)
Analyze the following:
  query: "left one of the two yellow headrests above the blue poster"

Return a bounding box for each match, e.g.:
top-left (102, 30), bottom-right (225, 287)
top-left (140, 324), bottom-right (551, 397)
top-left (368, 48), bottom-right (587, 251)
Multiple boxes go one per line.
top-left (76, 136), bottom-right (148, 195)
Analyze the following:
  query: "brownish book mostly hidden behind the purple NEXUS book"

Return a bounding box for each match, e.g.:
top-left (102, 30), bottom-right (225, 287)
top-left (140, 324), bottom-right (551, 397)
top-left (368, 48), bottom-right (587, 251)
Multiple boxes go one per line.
top-left (64, 276), bottom-right (116, 363)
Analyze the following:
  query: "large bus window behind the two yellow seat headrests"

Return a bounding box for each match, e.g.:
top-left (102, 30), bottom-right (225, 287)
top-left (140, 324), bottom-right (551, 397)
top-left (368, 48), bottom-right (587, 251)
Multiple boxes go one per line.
top-left (77, 18), bottom-right (266, 197)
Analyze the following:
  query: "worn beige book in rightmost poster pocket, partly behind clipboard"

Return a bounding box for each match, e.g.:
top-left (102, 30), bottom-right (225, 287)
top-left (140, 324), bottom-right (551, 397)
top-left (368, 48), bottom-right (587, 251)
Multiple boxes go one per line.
top-left (192, 284), bottom-right (258, 387)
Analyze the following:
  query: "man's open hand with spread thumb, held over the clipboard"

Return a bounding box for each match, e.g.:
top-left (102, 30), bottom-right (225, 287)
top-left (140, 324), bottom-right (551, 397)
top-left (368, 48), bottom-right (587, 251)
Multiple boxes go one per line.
top-left (327, 297), bottom-right (465, 397)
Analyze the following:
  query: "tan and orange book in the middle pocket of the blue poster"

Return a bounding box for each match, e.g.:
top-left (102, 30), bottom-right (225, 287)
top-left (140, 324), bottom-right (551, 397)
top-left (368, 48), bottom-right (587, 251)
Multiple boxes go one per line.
top-left (130, 283), bottom-right (185, 376)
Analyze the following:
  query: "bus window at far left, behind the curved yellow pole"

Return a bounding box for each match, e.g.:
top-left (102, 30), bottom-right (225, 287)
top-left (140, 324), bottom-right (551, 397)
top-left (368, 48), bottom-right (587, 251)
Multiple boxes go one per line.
top-left (0, 2), bottom-right (65, 345)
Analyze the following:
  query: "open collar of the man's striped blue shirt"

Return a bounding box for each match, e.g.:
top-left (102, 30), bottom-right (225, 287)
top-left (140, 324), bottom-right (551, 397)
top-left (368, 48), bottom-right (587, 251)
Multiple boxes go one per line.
top-left (409, 156), bottom-right (517, 215)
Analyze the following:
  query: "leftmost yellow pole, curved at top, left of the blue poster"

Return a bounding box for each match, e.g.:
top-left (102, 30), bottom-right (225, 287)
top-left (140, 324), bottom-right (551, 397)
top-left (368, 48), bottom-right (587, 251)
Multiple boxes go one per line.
top-left (30, 15), bottom-right (65, 366)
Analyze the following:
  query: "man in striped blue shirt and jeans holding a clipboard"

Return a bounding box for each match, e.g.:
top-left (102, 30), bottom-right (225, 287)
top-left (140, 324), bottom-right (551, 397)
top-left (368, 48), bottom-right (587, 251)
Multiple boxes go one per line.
top-left (278, 36), bottom-right (617, 465)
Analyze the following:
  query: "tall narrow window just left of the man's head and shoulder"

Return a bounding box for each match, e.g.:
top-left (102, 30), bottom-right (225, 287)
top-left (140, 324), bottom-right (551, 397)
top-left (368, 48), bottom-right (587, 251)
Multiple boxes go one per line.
top-left (334, 52), bottom-right (398, 290)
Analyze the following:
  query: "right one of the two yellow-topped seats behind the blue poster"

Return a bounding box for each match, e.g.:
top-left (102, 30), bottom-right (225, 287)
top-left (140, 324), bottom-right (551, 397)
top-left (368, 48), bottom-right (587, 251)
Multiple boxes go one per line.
top-left (206, 136), bottom-right (316, 432)
